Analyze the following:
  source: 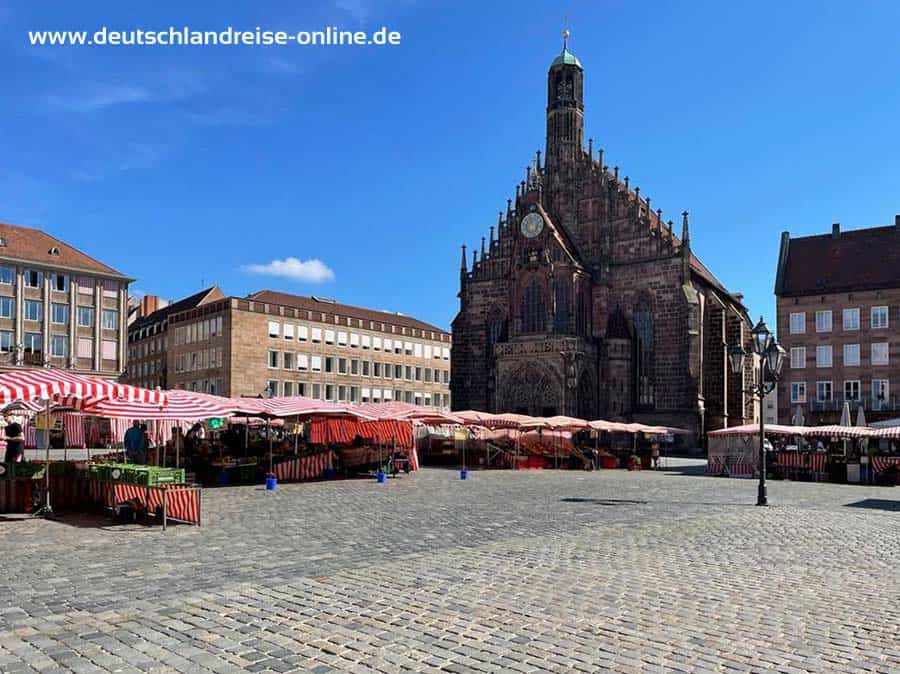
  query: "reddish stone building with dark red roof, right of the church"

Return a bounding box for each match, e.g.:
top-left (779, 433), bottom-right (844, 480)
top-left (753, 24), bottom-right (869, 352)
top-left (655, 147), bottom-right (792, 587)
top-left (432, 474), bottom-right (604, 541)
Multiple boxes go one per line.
top-left (775, 215), bottom-right (900, 424)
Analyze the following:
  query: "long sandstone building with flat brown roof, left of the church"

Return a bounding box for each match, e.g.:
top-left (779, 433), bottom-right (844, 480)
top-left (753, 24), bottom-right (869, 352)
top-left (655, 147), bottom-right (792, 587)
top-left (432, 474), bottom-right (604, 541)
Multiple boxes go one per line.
top-left (167, 290), bottom-right (451, 408)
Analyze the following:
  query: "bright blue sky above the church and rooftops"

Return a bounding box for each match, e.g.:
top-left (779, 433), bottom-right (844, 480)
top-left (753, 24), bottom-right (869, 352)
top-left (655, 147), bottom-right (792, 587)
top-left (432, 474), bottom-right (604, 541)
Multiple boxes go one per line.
top-left (0, 0), bottom-right (900, 327)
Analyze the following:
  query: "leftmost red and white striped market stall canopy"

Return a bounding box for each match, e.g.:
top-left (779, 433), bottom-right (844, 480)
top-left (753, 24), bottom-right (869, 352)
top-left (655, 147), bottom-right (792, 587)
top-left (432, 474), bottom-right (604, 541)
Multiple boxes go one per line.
top-left (0, 369), bottom-right (166, 405)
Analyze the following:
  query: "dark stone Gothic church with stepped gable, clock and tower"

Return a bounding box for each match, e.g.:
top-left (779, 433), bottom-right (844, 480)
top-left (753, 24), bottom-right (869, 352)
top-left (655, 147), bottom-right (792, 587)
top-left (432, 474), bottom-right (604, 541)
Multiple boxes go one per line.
top-left (451, 43), bottom-right (754, 436)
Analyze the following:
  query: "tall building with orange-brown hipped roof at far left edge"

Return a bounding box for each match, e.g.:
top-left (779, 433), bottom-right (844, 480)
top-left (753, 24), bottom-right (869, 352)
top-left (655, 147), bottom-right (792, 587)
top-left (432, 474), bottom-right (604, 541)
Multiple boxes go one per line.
top-left (0, 223), bottom-right (132, 377)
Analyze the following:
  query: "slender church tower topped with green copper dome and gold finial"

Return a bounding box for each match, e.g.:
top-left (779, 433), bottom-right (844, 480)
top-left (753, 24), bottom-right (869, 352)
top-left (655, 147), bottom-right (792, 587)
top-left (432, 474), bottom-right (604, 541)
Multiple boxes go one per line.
top-left (545, 30), bottom-right (584, 171)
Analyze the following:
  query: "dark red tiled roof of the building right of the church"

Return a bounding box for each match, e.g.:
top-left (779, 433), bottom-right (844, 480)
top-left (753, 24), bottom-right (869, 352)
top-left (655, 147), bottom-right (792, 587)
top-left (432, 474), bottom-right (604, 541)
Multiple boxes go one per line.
top-left (775, 226), bottom-right (900, 295)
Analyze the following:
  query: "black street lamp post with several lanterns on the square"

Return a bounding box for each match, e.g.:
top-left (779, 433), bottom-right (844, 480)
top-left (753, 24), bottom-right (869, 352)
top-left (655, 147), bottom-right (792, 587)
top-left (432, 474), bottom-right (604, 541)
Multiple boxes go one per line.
top-left (728, 316), bottom-right (785, 506)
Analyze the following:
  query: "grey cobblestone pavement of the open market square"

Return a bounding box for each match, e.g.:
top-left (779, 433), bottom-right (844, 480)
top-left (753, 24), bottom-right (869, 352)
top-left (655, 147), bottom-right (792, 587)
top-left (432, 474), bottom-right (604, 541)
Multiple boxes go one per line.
top-left (0, 462), bottom-right (900, 674)
